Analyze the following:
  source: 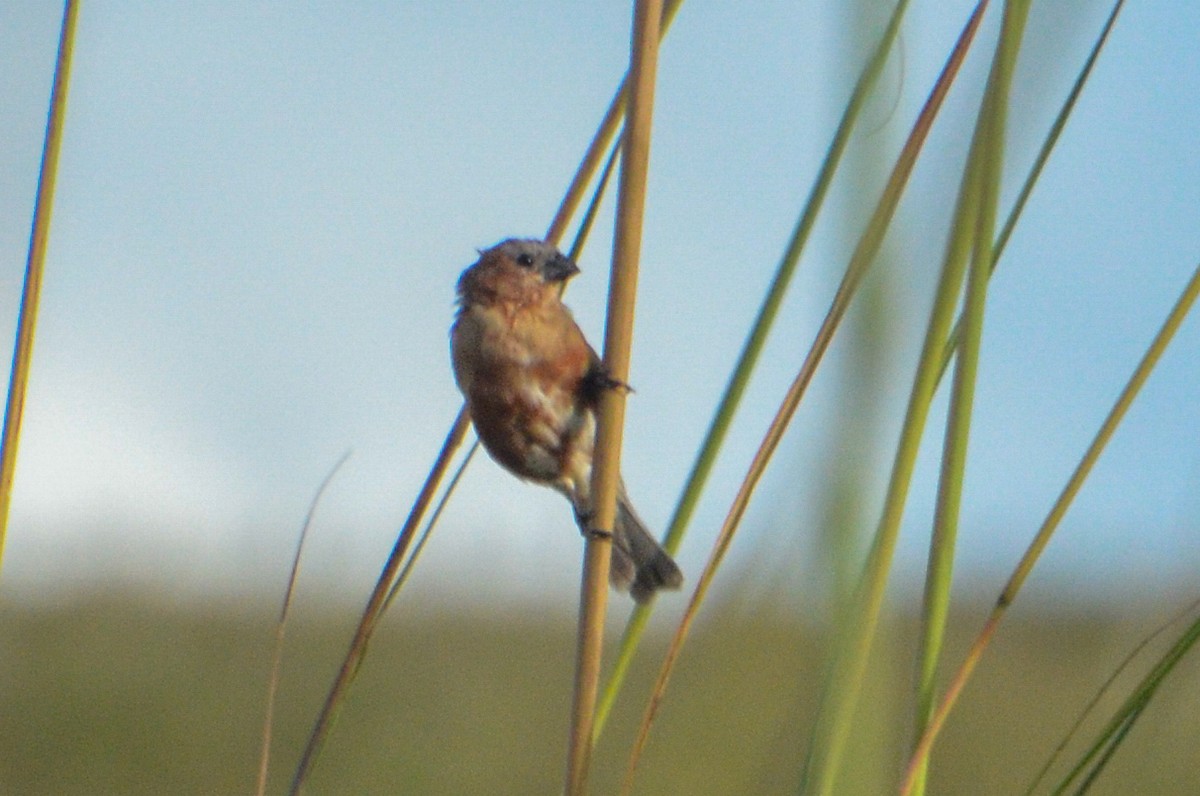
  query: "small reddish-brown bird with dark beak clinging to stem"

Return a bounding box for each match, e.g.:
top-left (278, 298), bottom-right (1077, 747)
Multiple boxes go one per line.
top-left (450, 238), bottom-right (683, 603)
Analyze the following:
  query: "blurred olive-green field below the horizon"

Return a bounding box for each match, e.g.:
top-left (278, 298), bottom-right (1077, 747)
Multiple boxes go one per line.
top-left (0, 594), bottom-right (1200, 796)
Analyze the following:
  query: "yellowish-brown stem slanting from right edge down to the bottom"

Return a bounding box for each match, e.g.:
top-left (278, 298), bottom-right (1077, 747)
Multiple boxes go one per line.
top-left (901, 258), bottom-right (1200, 794)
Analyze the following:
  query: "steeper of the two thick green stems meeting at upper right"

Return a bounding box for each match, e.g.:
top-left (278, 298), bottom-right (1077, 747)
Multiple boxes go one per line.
top-left (913, 2), bottom-right (1028, 794)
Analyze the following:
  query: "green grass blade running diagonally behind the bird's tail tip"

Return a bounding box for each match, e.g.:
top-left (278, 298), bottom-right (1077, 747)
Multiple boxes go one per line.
top-left (594, 0), bottom-right (908, 740)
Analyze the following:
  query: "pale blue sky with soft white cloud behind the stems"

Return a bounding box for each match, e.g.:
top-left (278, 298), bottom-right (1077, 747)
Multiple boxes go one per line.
top-left (0, 0), bottom-right (1200, 602)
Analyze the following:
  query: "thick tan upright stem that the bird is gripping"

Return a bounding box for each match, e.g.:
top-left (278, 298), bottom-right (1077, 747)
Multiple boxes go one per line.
top-left (565, 0), bottom-right (662, 796)
